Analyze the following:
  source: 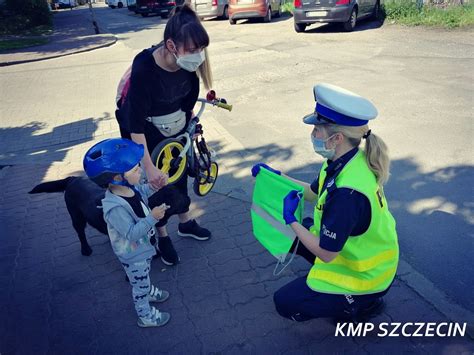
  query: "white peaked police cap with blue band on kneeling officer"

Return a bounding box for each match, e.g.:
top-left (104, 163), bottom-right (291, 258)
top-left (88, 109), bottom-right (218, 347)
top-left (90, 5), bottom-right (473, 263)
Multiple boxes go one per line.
top-left (303, 83), bottom-right (378, 126)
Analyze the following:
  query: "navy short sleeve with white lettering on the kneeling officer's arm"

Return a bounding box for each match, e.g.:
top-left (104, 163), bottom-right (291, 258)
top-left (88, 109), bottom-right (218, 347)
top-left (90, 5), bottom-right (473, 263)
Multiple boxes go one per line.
top-left (319, 188), bottom-right (371, 252)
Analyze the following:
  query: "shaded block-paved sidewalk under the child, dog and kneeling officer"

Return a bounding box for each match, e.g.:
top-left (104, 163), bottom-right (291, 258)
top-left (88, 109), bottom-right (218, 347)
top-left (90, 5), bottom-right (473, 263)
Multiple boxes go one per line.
top-left (0, 163), bottom-right (474, 354)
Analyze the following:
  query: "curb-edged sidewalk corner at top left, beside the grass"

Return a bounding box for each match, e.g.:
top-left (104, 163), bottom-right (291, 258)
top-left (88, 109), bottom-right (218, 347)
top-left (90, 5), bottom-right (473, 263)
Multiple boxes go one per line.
top-left (0, 6), bottom-right (117, 66)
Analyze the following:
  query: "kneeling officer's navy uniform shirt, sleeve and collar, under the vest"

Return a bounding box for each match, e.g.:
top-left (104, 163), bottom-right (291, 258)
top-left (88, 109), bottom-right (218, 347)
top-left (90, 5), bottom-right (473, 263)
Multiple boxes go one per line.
top-left (311, 148), bottom-right (372, 252)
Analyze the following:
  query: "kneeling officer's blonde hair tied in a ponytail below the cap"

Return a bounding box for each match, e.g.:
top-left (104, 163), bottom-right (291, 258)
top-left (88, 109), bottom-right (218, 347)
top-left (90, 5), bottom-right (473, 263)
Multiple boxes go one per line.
top-left (324, 124), bottom-right (390, 187)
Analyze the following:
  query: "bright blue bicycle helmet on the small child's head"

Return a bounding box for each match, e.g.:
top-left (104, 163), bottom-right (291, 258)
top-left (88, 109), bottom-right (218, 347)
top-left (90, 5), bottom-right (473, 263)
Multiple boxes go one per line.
top-left (83, 138), bottom-right (144, 187)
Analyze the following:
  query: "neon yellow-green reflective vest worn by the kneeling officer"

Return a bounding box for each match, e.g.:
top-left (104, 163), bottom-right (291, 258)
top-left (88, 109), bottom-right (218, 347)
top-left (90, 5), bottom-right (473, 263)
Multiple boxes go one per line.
top-left (306, 151), bottom-right (398, 295)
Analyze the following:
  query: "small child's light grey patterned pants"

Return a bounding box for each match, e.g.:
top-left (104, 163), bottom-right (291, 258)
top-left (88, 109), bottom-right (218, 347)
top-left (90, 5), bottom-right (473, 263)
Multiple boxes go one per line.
top-left (122, 259), bottom-right (151, 318)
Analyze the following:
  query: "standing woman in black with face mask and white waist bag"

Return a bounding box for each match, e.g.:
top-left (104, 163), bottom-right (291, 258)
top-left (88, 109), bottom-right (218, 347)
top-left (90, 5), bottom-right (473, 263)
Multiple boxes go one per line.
top-left (116, 5), bottom-right (212, 265)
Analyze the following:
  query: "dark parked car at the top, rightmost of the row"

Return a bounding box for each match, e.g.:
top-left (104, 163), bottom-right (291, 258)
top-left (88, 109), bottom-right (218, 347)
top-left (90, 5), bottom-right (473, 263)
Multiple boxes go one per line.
top-left (293, 0), bottom-right (380, 32)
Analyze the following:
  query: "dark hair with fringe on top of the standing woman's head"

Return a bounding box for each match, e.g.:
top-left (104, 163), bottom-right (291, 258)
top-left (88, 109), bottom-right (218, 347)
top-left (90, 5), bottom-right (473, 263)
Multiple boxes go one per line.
top-left (164, 4), bottom-right (209, 49)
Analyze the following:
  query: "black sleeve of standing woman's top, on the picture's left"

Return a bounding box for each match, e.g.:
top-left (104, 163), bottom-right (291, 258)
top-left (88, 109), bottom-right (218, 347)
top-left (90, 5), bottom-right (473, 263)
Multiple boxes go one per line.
top-left (122, 53), bottom-right (152, 134)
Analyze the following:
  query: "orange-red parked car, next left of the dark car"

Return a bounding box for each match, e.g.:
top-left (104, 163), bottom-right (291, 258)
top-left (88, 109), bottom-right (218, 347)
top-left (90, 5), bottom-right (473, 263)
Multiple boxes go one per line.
top-left (229, 0), bottom-right (283, 25)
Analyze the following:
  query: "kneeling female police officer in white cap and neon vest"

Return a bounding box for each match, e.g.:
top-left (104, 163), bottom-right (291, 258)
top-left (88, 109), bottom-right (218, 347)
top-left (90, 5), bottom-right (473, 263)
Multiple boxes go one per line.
top-left (252, 84), bottom-right (398, 321)
